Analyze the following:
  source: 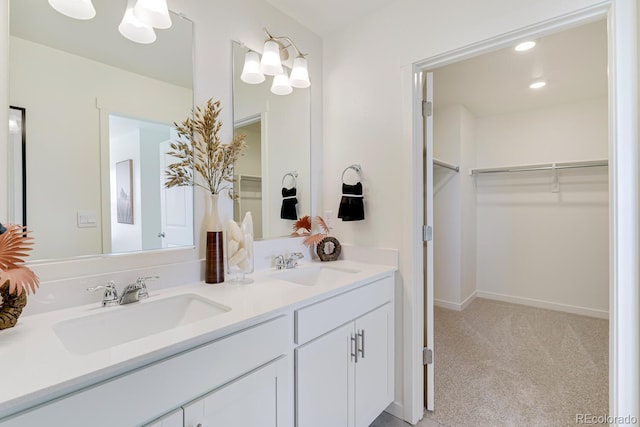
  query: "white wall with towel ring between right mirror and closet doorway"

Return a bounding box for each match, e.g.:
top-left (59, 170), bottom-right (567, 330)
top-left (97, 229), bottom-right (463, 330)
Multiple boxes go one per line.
top-left (322, 0), bottom-right (599, 422)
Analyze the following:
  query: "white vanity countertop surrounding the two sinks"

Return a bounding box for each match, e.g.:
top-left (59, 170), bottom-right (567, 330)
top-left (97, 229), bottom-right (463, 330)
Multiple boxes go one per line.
top-left (0, 261), bottom-right (395, 419)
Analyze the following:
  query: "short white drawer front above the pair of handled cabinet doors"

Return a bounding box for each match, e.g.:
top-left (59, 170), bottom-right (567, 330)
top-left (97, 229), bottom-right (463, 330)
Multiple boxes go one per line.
top-left (295, 276), bottom-right (393, 345)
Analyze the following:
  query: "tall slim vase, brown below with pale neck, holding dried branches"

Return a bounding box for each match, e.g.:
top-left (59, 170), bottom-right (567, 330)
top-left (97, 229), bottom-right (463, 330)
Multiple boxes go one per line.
top-left (204, 194), bottom-right (224, 283)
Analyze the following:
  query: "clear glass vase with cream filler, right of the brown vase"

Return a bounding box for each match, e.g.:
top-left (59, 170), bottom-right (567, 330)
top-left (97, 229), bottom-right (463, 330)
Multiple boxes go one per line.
top-left (227, 212), bottom-right (253, 284)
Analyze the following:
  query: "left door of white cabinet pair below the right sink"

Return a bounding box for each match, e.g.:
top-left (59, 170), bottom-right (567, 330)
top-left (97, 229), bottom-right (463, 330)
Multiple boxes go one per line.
top-left (295, 322), bottom-right (355, 427)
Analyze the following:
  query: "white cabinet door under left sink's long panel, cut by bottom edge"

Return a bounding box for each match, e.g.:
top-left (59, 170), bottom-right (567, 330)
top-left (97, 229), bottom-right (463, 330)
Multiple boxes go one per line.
top-left (183, 362), bottom-right (278, 427)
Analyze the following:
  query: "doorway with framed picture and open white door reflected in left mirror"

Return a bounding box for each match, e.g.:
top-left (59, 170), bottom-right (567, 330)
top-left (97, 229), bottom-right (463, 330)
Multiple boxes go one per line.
top-left (105, 114), bottom-right (193, 252)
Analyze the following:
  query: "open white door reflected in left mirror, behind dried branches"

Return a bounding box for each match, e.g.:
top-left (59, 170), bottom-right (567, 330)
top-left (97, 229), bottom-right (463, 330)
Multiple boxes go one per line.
top-left (158, 139), bottom-right (193, 248)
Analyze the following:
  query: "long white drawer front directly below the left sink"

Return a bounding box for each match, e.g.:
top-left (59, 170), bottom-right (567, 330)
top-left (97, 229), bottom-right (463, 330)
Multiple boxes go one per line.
top-left (0, 316), bottom-right (290, 427)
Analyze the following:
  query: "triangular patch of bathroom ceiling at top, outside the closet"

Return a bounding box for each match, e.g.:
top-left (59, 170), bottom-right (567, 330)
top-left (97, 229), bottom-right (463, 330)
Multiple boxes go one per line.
top-left (267, 0), bottom-right (394, 37)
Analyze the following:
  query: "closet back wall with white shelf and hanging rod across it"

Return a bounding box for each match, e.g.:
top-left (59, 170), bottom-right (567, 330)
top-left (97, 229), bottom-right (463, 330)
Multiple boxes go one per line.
top-left (476, 99), bottom-right (609, 317)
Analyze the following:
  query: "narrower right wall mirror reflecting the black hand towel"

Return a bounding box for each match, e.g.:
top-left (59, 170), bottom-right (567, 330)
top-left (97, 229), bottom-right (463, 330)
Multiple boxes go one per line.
top-left (233, 42), bottom-right (311, 239)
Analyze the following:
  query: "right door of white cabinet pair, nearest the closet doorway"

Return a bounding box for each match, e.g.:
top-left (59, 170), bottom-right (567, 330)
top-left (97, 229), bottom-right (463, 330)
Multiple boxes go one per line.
top-left (355, 304), bottom-right (394, 427)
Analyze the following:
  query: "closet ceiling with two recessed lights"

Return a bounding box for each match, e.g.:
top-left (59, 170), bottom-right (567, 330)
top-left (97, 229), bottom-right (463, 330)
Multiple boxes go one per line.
top-left (433, 20), bottom-right (607, 117)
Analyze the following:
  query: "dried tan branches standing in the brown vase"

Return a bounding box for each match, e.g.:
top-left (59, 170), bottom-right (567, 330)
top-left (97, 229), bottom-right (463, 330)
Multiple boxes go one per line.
top-left (165, 99), bottom-right (246, 197)
